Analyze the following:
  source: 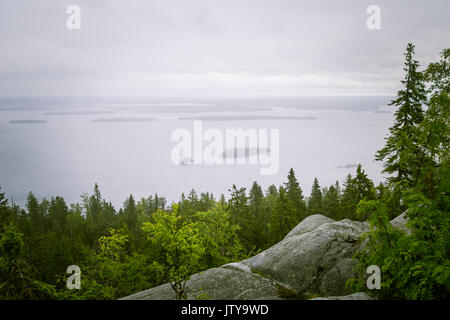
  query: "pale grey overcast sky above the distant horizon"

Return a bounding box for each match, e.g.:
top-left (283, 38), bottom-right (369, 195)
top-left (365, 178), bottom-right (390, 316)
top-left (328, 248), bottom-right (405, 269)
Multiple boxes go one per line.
top-left (0, 0), bottom-right (450, 97)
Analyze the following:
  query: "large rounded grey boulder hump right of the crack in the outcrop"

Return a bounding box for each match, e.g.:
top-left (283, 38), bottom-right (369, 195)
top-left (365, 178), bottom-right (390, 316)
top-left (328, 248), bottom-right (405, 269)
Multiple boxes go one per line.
top-left (242, 215), bottom-right (369, 298)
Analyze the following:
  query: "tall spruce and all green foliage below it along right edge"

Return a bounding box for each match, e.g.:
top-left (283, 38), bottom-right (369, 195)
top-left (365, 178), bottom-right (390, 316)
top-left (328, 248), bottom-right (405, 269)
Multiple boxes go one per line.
top-left (352, 46), bottom-right (450, 300)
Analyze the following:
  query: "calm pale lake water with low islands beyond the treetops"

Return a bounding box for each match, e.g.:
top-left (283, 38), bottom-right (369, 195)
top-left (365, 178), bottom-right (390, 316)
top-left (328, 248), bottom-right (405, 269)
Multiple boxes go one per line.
top-left (0, 97), bottom-right (393, 206)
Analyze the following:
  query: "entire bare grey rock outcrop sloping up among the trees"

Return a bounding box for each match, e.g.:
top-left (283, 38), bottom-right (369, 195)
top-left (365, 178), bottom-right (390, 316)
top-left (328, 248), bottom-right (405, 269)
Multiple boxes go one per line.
top-left (122, 215), bottom-right (369, 300)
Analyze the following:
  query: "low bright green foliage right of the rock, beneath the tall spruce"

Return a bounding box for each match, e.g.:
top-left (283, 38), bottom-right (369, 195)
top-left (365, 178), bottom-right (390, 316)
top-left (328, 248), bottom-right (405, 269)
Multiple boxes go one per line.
top-left (354, 190), bottom-right (450, 300)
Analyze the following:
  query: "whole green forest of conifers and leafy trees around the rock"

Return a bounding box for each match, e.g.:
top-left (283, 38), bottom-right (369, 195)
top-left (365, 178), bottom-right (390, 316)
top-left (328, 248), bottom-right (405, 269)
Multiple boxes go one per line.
top-left (0, 44), bottom-right (450, 299)
